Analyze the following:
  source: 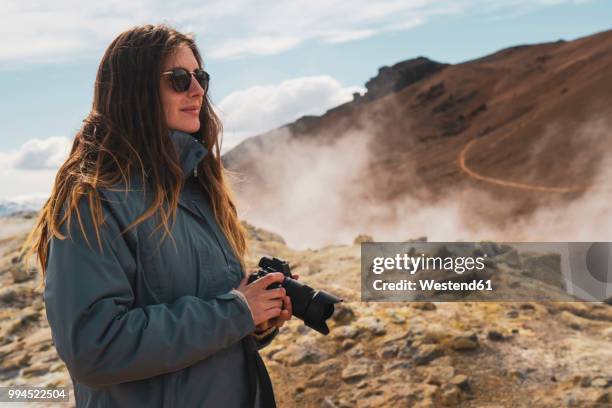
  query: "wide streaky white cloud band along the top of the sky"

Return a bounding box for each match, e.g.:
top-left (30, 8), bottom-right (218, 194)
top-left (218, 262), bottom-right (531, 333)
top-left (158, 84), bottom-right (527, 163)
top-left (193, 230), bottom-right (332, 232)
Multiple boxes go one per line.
top-left (0, 0), bottom-right (585, 67)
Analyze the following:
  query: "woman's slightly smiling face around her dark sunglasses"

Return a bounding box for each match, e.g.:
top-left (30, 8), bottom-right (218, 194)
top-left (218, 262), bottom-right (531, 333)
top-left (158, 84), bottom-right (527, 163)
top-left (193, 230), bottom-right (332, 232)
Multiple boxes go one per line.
top-left (159, 45), bottom-right (204, 133)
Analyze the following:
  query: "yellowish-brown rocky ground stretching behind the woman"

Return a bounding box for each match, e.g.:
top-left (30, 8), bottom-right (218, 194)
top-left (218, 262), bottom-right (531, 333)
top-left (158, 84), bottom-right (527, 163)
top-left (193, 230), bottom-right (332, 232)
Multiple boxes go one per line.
top-left (0, 217), bottom-right (612, 408)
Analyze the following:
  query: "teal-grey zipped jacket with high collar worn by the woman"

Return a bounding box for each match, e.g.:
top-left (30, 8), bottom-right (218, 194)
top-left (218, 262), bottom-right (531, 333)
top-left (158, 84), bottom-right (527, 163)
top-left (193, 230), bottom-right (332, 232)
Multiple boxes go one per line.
top-left (44, 131), bottom-right (278, 407)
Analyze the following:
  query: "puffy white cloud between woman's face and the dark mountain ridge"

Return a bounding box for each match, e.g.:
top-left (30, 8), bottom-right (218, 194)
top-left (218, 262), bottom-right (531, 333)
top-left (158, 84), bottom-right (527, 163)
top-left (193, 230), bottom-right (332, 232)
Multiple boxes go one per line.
top-left (218, 75), bottom-right (365, 151)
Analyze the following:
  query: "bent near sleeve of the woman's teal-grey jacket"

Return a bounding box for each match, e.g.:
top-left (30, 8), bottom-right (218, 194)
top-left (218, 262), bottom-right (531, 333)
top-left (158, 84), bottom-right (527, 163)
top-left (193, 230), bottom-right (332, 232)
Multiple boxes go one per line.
top-left (44, 199), bottom-right (255, 387)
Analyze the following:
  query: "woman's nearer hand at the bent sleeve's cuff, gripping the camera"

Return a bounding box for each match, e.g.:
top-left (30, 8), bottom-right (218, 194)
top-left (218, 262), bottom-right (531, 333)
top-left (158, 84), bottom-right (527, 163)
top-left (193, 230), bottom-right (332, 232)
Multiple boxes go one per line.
top-left (236, 272), bottom-right (287, 326)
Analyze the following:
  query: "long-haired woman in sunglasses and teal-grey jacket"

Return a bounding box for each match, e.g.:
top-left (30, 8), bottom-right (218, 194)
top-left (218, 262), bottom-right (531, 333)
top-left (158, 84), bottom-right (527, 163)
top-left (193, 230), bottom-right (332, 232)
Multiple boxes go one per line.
top-left (26, 25), bottom-right (297, 407)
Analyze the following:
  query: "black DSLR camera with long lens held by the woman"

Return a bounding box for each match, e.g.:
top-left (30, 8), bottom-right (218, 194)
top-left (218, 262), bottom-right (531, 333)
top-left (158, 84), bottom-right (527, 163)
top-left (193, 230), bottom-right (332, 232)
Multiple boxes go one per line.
top-left (247, 256), bottom-right (342, 335)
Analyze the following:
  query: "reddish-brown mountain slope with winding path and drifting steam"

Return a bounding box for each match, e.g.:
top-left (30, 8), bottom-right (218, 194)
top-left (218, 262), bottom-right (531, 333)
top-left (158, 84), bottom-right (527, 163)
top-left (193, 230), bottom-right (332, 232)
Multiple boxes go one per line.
top-left (224, 31), bottom-right (612, 245)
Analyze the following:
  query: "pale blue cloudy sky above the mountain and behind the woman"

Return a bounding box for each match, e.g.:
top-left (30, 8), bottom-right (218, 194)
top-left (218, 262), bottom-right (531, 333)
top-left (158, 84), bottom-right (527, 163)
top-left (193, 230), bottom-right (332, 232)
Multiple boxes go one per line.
top-left (0, 0), bottom-right (612, 201)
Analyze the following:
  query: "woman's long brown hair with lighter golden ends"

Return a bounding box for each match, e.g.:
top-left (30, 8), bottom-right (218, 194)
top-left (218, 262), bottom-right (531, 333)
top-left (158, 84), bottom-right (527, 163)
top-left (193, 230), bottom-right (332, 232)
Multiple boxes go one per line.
top-left (22, 24), bottom-right (247, 282)
